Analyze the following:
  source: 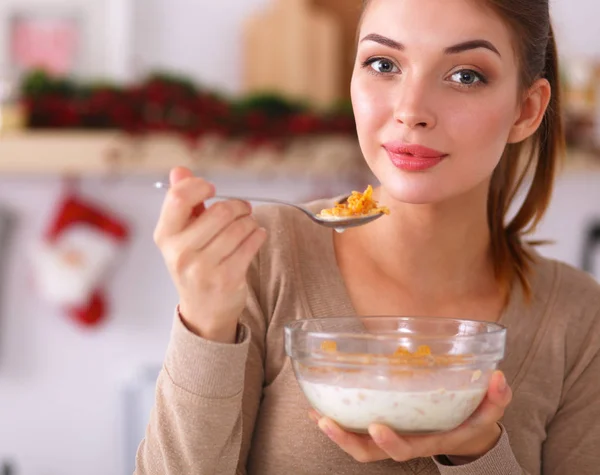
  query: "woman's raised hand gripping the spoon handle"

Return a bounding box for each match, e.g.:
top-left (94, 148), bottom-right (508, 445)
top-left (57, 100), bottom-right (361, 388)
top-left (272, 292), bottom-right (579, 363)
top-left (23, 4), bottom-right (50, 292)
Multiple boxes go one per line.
top-left (154, 168), bottom-right (266, 343)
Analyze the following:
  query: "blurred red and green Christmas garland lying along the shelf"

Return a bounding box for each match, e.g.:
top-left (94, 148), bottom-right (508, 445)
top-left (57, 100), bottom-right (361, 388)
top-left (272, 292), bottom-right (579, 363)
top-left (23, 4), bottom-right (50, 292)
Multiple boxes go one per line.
top-left (20, 71), bottom-right (356, 144)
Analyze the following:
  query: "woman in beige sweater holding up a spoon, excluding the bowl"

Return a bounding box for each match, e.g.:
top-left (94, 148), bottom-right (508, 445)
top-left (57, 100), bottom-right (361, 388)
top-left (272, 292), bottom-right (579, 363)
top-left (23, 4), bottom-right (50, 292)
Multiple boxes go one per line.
top-left (136, 0), bottom-right (600, 475)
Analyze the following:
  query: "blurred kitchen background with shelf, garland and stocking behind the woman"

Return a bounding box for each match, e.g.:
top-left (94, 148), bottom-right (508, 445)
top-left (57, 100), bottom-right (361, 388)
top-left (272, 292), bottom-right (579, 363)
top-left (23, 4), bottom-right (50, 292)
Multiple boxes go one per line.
top-left (0, 0), bottom-right (600, 475)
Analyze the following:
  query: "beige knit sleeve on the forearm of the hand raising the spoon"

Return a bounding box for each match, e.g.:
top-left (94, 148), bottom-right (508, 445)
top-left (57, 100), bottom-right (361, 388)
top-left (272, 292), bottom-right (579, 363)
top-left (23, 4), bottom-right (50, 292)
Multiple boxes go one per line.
top-left (135, 264), bottom-right (266, 475)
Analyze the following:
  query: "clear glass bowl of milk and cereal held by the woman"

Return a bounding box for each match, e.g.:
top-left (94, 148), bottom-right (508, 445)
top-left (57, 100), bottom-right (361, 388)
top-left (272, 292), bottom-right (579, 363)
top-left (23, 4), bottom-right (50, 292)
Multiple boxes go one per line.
top-left (285, 317), bottom-right (506, 434)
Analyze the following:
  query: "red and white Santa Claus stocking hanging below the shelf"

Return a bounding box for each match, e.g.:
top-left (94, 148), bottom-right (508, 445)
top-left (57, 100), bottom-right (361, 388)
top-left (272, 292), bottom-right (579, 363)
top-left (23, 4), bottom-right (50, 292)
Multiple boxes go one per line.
top-left (34, 194), bottom-right (128, 326)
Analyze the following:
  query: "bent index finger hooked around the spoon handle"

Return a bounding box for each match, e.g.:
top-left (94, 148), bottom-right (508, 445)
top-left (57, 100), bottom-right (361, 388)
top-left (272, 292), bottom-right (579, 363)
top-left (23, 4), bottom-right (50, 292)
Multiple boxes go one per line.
top-left (154, 174), bottom-right (215, 244)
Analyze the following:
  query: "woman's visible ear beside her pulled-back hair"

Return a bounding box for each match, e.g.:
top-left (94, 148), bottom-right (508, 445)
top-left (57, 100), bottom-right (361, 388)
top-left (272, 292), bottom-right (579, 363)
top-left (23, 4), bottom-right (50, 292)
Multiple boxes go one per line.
top-left (508, 79), bottom-right (552, 143)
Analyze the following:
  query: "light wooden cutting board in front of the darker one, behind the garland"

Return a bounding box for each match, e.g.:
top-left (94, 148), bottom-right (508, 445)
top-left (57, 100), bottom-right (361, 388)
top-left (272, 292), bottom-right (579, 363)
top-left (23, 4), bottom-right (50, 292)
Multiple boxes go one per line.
top-left (243, 0), bottom-right (352, 107)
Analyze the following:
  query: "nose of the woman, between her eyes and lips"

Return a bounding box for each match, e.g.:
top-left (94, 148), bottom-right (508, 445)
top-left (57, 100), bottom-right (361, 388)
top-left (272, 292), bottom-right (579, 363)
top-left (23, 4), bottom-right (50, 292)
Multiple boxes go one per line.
top-left (394, 78), bottom-right (437, 129)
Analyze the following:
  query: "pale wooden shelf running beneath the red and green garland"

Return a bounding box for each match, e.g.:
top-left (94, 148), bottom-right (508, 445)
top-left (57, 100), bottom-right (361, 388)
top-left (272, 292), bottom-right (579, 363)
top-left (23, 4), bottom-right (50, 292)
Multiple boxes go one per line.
top-left (0, 131), bottom-right (365, 177)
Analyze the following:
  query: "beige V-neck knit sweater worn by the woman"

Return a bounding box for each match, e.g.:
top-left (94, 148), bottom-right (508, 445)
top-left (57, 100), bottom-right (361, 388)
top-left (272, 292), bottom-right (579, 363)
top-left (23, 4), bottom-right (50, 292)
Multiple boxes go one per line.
top-left (135, 203), bottom-right (600, 475)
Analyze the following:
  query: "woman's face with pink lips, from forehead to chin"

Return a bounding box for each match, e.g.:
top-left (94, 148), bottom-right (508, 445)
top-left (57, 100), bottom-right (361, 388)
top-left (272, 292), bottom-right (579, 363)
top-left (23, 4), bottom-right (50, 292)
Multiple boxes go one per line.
top-left (352, 0), bottom-right (519, 204)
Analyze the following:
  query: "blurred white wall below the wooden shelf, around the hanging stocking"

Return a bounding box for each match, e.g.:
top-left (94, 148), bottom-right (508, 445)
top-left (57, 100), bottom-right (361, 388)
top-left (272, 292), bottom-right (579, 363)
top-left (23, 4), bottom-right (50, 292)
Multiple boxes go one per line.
top-left (0, 177), bottom-right (347, 475)
